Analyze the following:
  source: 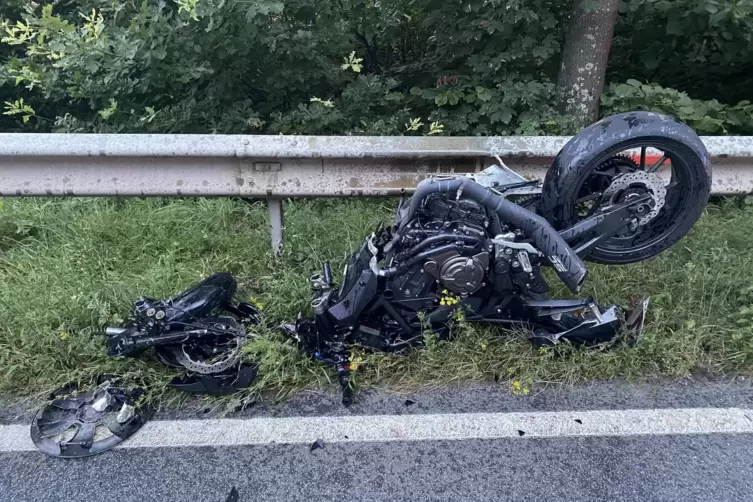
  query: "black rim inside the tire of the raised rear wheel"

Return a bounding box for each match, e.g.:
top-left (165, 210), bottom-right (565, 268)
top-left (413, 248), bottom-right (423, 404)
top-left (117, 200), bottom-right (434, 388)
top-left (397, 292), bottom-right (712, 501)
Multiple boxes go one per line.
top-left (570, 140), bottom-right (694, 255)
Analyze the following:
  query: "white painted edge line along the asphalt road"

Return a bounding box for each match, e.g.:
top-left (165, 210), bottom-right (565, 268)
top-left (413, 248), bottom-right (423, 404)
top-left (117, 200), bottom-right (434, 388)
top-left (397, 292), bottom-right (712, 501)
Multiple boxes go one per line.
top-left (0, 408), bottom-right (753, 452)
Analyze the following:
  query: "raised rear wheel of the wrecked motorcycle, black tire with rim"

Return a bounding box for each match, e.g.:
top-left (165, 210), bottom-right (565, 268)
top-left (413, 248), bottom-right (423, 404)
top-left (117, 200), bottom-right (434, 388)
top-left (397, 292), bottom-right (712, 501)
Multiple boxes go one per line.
top-left (540, 112), bottom-right (711, 265)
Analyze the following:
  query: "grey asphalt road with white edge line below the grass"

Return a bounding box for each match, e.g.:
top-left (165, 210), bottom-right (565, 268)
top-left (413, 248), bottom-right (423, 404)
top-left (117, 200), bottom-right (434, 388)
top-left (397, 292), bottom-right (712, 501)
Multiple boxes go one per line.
top-left (0, 381), bottom-right (753, 502)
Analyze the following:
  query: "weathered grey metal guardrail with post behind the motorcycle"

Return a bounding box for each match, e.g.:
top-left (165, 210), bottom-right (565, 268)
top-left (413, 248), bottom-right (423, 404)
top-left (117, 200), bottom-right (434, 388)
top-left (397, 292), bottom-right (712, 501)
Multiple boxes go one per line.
top-left (0, 134), bottom-right (753, 249)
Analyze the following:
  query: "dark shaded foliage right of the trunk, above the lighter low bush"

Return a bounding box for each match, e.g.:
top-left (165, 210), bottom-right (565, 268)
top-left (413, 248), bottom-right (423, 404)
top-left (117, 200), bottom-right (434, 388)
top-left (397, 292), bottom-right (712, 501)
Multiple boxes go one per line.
top-left (609, 0), bottom-right (753, 103)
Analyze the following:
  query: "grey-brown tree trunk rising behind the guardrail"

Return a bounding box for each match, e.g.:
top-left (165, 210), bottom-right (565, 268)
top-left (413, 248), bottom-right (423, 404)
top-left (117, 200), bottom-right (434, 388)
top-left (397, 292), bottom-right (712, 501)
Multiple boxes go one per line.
top-left (557, 0), bottom-right (620, 125)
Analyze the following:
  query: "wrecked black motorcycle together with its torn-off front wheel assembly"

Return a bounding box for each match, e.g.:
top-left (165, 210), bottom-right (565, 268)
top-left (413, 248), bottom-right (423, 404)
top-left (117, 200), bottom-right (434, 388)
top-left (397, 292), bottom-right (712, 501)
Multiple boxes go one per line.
top-left (108, 112), bottom-right (711, 405)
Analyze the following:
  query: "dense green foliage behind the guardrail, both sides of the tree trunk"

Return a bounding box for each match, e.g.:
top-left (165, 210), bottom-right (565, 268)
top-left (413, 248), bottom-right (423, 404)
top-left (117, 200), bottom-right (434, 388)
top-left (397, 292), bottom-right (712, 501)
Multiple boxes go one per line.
top-left (0, 0), bottom-right (753, 135)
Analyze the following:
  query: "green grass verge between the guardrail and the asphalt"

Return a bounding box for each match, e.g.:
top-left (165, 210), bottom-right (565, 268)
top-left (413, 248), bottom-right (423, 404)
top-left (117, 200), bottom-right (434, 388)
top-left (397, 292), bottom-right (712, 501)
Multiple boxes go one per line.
top-left (0, 199), bottom-right (753, 403)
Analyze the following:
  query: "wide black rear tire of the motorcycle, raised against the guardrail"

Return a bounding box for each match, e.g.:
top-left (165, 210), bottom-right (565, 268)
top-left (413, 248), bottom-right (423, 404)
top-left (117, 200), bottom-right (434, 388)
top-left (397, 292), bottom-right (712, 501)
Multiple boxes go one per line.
top-left (539, 112), bottom-right (711, 265)
